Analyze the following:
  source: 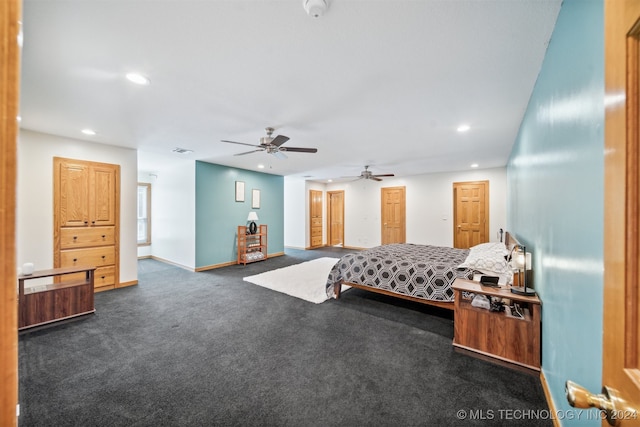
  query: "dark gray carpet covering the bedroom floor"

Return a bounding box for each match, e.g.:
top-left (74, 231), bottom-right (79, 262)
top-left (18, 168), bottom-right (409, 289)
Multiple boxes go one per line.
top-left (19, 249), bottom-right (552, 427)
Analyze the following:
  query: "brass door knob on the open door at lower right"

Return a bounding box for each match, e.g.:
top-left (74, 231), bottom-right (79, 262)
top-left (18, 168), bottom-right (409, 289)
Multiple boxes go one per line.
top-left (564, 381), bottom-right (628, 426)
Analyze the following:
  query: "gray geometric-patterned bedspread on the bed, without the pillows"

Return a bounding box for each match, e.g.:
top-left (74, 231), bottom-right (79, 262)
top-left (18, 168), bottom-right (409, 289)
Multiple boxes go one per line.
top-left (327, 243), bottom-right (473, 301)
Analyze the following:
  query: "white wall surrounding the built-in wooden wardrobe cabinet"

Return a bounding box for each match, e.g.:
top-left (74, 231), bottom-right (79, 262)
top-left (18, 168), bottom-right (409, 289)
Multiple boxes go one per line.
top-left (16, 130), bottom-right (138, 282)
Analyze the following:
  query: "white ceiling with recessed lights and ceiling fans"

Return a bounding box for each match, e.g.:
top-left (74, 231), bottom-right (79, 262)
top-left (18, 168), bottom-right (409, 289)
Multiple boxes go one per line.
top-left (21, 0), bottom-right (561, 180)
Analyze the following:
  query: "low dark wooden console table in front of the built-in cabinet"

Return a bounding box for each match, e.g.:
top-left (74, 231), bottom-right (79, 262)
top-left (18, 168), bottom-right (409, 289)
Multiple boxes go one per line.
top-left (18, 267), bottom-right (96, 330)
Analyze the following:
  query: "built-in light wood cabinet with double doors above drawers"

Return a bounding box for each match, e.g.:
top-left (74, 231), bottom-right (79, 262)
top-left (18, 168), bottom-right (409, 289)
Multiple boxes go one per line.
top-left (53, 157), bottom-right (120, 291)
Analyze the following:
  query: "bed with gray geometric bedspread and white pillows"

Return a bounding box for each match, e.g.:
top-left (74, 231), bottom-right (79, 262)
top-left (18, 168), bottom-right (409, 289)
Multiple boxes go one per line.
top-left (326, 236), bottom-right (511, 310)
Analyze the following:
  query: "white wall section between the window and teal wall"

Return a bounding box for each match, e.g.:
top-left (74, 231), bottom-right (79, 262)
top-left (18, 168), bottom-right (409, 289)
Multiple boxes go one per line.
top-left (138, 151), bottom-right (196, 269)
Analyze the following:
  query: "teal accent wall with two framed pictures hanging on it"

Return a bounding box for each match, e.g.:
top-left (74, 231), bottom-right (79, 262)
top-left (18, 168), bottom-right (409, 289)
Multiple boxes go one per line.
top-left (195, 161), bottom-right (284, 268)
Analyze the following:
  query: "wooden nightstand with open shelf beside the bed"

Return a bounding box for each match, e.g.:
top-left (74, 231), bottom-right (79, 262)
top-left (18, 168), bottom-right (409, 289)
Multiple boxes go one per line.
top-left (453, 279), bottom-right (541, 371)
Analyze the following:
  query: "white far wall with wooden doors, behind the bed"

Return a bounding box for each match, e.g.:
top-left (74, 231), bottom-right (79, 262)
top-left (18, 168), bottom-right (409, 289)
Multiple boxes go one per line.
top-left (285, 168), bottom-right (507, 248)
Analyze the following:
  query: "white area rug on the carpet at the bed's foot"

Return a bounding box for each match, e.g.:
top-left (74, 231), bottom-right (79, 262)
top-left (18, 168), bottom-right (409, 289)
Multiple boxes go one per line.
top-left (242, 257), bottom-right (347, 304)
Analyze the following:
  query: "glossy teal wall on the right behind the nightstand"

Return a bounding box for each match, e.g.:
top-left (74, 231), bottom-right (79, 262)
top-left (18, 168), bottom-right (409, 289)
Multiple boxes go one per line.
top-left (507, 0), bottom-right (604, 426)
